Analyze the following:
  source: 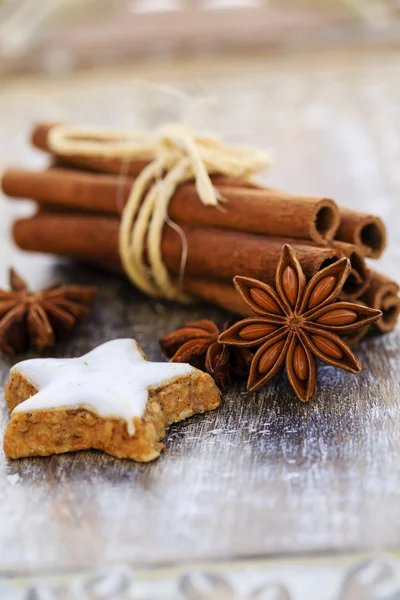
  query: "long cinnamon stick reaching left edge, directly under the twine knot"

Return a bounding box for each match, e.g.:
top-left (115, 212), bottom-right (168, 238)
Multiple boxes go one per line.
top-left (1, 168), bottom-right (339, 244)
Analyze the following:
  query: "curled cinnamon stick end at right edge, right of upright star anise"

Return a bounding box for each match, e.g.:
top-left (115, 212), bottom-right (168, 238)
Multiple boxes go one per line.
top-left (361, 271), bottom-right (400, 333)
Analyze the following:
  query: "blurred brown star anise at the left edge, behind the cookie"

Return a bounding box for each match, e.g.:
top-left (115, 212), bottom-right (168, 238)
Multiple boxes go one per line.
top-left (0, 269), bottom-right (97, 354)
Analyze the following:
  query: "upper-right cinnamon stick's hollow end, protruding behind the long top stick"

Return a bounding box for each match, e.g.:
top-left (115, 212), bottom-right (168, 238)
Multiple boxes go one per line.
top-left (335, 207), bottom-right (387, 258)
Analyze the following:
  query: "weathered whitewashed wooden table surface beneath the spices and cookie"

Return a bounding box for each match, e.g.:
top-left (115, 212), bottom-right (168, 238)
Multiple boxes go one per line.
top-left (0, 49), bottom-right (400, 598)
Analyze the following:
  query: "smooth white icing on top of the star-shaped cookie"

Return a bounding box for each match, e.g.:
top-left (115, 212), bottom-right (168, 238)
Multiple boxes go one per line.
top-left (11, 339), bottom-right (195, 435)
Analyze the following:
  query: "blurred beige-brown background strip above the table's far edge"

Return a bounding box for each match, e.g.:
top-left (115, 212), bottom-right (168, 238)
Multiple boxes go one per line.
top-left (0, 0), bottom-right (400, 74)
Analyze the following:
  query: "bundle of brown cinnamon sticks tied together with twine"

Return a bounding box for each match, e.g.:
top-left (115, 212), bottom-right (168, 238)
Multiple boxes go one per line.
top-left (1, 124), bottom-right (400, 342)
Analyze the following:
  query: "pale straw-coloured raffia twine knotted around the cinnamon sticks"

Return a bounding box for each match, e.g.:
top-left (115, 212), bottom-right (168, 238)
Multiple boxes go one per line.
top-left (48, 124), bottom-right (271, 302)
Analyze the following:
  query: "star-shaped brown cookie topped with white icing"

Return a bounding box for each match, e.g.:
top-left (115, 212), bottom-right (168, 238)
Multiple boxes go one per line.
top-left (4, 339), bottom-right (220, 462)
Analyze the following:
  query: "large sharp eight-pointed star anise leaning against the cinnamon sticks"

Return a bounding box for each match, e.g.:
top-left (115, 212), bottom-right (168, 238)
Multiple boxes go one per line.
top-left (219, 245), bottom-right (382, 402)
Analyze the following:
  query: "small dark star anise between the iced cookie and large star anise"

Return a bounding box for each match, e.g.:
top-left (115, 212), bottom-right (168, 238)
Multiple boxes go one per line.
top-left (159, 319), bottom-right (253, 390)
